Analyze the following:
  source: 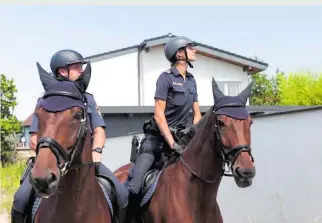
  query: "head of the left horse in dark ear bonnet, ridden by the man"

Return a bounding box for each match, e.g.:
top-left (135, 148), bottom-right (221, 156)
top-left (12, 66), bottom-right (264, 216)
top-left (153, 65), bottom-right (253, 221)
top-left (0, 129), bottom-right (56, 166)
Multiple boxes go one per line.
top-left (30, 63), bottom-right (92, 197)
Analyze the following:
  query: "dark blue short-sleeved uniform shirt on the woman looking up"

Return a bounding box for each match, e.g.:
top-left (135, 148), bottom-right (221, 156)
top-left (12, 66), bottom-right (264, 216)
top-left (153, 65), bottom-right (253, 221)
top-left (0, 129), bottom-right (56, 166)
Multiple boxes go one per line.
top-left (154, 67), bottom-right (198, 127)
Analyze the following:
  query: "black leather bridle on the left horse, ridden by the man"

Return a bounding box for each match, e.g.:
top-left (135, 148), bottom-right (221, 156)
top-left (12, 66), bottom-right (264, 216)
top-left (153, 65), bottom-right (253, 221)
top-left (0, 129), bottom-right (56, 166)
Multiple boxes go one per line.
top-left (36, 91), bottom-right (95, 176)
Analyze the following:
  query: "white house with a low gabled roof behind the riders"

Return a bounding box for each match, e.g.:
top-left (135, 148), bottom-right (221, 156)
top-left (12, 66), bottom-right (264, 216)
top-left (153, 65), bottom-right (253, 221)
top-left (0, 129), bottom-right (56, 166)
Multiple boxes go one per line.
top-left (86, 33), bottom-right (268, 106)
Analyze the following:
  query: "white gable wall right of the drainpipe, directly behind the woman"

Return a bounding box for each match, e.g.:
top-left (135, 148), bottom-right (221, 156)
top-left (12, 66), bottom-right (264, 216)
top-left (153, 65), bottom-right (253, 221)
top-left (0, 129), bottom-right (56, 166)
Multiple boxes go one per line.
top-left (141, 46), bottom-right (248, 106)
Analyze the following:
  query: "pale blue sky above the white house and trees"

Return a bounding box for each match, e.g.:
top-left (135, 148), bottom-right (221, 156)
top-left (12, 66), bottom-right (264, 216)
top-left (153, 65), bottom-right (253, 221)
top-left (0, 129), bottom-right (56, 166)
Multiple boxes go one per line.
top-left (0, 6), bottom-right (322, 120)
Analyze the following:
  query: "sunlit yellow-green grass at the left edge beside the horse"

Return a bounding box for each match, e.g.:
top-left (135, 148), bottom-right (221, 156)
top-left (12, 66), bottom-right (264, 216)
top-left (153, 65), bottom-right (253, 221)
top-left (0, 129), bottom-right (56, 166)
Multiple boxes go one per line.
top-left (0, 161), bottom-right (26, 213)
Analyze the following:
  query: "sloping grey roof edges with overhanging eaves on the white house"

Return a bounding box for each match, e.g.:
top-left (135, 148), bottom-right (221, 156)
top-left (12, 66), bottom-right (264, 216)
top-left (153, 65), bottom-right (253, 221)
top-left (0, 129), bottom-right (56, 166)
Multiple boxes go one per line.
top-left (86, 33), bottom-right (268, 74)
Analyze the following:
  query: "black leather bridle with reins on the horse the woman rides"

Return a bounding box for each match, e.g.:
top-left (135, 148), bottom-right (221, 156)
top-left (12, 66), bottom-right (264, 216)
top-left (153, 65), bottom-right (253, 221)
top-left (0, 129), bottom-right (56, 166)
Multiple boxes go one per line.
top-left (180, 103), bottom-right (254, 183)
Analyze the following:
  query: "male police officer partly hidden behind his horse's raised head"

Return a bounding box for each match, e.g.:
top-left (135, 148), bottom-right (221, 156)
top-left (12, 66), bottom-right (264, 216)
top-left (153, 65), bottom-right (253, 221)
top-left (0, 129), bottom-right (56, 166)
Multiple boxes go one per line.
top-left (12, 50), bottom-right (128, 223)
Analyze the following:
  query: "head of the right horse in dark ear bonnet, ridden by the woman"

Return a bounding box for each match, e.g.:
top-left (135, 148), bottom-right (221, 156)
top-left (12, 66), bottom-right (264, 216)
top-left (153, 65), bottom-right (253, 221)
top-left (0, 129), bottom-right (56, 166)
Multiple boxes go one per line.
top-left (212, 79), bottom-right (255, 187)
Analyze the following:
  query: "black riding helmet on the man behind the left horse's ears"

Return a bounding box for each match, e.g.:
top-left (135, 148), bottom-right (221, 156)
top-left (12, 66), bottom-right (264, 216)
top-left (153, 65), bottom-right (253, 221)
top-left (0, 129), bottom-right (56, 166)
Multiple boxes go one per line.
top-left (50, 50), bottom-right (87, 78)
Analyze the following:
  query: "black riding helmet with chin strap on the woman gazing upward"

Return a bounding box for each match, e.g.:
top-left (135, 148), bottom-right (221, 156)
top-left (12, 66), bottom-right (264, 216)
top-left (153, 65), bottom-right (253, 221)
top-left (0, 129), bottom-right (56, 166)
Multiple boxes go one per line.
top-left (164, 36), bottom-right (197, 68)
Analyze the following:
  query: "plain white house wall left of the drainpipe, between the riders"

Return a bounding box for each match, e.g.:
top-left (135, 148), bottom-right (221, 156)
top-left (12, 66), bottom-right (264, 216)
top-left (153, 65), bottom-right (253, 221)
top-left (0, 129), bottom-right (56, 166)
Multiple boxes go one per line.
top-left (87, 53), bottom-right (138, 106)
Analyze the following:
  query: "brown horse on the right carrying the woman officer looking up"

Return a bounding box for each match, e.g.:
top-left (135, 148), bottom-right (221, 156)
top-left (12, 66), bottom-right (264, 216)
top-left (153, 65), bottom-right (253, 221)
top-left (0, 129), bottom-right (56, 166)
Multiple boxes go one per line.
top-left (114, 79), bottom-right (255, 223)
